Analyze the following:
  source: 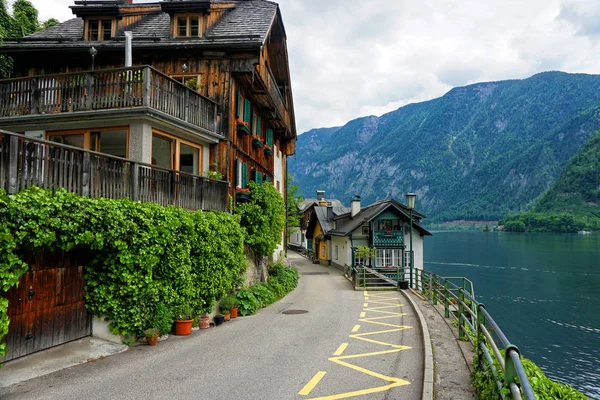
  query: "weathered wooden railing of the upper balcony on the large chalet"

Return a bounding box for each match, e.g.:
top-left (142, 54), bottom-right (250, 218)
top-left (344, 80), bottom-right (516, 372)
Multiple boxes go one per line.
top-left (0, 66), bottom-right (217, 133)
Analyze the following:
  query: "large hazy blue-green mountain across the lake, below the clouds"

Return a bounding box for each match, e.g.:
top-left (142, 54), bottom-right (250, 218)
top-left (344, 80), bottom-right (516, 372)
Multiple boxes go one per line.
top-left (290, 72), bottom-right (600, 223)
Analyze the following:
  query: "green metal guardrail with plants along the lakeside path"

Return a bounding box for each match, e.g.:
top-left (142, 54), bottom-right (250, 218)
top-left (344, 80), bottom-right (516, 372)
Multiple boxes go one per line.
top-left (415, 270), bottom-right (537, 400)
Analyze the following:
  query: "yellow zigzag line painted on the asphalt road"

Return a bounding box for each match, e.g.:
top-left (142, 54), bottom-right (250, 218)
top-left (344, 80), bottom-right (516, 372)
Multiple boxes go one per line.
top-left (299, 291), bottom-right (412, 400)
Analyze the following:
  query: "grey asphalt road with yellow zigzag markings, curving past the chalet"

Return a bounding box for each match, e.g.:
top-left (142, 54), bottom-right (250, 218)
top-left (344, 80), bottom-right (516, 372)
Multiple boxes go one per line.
top-left (0, 253), bottom-right (423, 400)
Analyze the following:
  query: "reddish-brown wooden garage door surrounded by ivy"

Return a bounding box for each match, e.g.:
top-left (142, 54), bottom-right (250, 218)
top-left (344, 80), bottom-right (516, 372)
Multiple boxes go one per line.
top-left (0, 252), bottom-right (91, 362)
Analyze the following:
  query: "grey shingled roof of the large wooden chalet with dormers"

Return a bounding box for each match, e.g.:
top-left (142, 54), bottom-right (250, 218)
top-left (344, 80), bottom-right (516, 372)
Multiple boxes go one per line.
top-left (0, 0), bottom-right (280, 51)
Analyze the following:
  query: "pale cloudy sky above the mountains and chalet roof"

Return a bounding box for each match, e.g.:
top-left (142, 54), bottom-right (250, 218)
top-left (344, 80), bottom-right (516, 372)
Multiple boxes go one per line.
top-left (24, 0), bottom-right (600, 132)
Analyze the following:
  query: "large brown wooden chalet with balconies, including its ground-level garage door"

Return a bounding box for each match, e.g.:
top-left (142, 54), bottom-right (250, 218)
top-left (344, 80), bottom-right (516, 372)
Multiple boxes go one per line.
top-left (0, 0), bottom-right (296, 362)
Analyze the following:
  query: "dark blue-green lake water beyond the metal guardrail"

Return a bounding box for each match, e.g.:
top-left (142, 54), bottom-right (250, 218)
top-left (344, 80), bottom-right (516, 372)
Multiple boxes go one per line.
top-left (424, 232), bottom-right (600, 399)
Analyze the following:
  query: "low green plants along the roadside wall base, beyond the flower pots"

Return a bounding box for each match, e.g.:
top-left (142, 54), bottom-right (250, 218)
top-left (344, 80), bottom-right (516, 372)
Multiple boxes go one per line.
top-left (236, 263), bottom-right (298, 316)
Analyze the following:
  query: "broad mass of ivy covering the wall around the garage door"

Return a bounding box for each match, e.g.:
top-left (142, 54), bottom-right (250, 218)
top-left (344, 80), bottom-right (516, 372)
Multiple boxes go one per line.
top-left (0, 188), bottom-right (247, 353)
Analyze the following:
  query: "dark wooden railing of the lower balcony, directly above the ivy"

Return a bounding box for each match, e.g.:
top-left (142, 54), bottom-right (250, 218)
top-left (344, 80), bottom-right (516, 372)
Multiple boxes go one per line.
top-left (0, 131), bottom-right (229, 211)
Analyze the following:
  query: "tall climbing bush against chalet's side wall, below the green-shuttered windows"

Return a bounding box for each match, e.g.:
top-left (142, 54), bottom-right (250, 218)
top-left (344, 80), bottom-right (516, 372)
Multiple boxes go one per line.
top-left (234, 182), bottom-right (285, 256)
